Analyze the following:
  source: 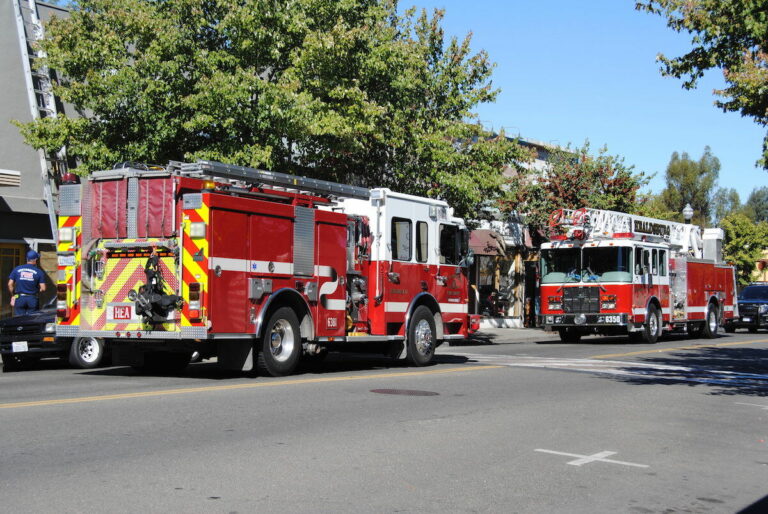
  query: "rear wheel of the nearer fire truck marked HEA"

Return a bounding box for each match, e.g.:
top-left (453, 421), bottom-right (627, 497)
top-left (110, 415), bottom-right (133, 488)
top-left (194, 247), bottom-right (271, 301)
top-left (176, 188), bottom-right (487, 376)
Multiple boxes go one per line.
top-left (258, 307), bottom-right (301, 377)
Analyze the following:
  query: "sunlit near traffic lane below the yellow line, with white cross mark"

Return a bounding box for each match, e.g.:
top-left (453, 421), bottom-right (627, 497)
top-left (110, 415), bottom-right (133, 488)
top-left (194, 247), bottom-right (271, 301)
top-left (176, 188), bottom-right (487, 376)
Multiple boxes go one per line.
top-left (0, 358), bottom-right (768, 512)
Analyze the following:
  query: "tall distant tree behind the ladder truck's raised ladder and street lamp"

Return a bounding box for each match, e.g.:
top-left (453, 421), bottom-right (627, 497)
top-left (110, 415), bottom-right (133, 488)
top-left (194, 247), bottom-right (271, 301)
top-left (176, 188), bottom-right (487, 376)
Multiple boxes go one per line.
top-left (661, 146), bottom-right (720, 226)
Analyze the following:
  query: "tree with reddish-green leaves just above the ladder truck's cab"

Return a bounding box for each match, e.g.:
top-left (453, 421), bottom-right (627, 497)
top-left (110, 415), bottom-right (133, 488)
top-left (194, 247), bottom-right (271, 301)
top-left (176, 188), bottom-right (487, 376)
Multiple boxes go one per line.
top-left (512, 142), bottom-right (649, 233)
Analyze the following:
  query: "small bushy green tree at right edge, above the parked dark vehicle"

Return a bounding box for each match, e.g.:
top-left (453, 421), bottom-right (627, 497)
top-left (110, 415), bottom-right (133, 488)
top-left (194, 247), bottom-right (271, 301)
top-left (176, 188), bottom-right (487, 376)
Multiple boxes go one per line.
top-left (721, 213), bottom-right (768, 285)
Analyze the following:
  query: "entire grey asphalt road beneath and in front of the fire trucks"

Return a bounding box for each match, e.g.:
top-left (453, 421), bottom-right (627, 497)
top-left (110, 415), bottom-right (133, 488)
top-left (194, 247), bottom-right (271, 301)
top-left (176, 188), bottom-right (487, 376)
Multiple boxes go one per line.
top-left (0, 329), bottom-right (768, 513)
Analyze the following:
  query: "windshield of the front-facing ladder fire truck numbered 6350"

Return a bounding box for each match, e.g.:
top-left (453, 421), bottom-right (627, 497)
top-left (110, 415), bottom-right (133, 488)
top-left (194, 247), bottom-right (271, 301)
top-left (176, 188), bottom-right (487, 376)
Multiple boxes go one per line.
top-left (541, 247), bottom-right (632, 284)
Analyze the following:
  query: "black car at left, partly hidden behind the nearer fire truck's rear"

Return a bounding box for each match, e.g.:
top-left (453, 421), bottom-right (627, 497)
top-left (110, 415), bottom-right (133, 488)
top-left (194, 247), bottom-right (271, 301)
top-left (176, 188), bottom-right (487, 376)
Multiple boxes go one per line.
top-left (0, 297), bottom-right (104, 371)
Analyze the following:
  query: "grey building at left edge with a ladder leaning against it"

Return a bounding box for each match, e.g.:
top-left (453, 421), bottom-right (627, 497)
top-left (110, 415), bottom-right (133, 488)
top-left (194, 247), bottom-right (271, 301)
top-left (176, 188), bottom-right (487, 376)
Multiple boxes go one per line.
top-left (0, 0), bottom-right (68, 317)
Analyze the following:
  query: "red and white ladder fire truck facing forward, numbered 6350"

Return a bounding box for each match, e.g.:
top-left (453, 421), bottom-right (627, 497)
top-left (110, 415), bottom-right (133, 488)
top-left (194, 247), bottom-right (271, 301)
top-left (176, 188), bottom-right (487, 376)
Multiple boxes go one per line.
top-left (539, 209), bottom-right (737, 343)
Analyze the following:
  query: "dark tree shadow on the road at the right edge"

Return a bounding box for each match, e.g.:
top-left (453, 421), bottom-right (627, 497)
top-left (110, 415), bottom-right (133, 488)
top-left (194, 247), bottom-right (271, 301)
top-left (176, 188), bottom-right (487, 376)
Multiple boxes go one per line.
top-left (610, 347), bottom-right (768, 396)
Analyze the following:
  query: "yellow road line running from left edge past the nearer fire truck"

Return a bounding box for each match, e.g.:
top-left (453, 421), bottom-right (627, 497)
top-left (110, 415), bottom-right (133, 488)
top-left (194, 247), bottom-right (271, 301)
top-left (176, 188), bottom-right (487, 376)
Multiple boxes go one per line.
top-left (0, 366), bottom-right (504, 409)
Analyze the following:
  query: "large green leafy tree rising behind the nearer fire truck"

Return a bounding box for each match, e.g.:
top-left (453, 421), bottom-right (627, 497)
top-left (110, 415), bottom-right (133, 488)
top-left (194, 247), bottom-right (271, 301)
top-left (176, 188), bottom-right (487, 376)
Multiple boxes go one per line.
top-left (16, 0), bottom-right (524, 215)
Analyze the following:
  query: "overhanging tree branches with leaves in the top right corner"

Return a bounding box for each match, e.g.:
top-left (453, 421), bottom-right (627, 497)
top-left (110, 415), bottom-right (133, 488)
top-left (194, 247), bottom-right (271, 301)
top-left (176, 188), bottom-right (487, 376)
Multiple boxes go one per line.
top-left (635, 0), bottom-right (768, 169)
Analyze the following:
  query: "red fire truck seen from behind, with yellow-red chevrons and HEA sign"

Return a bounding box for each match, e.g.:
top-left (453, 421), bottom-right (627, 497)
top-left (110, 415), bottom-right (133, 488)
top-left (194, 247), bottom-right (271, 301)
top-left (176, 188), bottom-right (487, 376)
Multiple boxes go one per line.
top-left (56, 161), bottom-right (479, 376)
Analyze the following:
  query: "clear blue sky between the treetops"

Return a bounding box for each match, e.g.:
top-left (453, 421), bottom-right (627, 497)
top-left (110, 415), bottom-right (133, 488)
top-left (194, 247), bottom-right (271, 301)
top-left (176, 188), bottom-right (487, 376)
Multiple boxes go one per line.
top-left (400, 0), bottom-right (768, 203)
